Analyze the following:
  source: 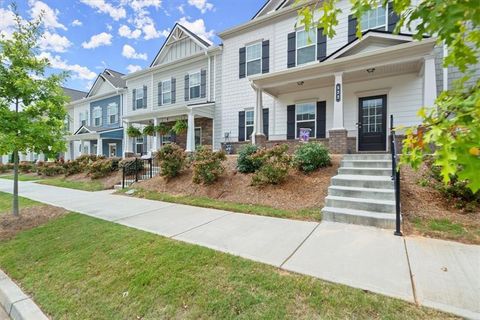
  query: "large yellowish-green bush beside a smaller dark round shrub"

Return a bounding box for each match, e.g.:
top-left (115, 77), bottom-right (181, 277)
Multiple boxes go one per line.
top-left (252, 144), bottom-right (292, 186)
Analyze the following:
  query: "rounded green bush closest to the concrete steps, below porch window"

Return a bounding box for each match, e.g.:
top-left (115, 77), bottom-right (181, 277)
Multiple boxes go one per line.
top-left (293, 142), bottom-right (331, 173)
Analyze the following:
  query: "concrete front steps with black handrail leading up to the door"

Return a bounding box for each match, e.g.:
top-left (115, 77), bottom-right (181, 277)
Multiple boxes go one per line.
top-left (322, 154), bottom-right (395, 229)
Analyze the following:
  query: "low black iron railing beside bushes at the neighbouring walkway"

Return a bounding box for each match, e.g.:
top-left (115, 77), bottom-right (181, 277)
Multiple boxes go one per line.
top-left (122, 158), bottom-right (160, 189)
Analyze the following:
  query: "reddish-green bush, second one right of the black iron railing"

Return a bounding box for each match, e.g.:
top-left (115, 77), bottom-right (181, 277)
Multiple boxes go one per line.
top-left (193, 146), bottom-right (227, 184)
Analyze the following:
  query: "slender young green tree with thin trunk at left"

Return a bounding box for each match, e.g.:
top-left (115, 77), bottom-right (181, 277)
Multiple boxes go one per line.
top-left (0, 5), bottom-right (68, 216)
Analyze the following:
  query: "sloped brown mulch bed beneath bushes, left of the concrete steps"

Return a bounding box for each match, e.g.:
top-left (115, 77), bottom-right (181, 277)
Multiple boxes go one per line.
top-left (136, 156), bottom-right (341, 210)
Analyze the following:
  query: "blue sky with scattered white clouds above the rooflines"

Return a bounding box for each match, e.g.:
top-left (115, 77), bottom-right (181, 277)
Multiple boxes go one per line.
top-left (0, 0), bottom-right (264, 91)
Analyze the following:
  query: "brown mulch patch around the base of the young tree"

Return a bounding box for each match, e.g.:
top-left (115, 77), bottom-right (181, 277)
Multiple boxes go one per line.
top-left (0, 205), bottom-right (67, 241)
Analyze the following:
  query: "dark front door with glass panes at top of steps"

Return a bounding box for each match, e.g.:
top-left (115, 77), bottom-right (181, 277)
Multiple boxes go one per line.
top-left (358, 95), bottom-right (387, 151)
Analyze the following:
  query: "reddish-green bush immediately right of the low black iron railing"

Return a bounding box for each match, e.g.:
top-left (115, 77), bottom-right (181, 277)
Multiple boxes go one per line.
top-left (156, 143), bottom-right (187, 178)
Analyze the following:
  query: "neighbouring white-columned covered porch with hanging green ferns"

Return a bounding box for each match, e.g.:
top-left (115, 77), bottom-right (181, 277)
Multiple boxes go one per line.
top-left (124, 102), bottom-right (215, 157)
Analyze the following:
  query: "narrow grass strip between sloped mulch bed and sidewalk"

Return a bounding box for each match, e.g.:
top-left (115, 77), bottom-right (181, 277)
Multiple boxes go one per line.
top-left (123, 189), bottom-right (322, 221)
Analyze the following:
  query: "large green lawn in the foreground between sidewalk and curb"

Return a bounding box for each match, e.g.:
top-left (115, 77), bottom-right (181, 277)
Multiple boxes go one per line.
top-left (0, 214), bottom-right (447, 320)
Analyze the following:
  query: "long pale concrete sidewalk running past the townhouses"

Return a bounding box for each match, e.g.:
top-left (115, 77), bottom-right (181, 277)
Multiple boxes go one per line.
top-left (0, 179), bottom-right (480, 319)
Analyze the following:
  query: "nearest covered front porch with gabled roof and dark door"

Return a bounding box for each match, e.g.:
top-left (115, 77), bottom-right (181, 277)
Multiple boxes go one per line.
top-left (250, 33), bottom-right (437, 154)
